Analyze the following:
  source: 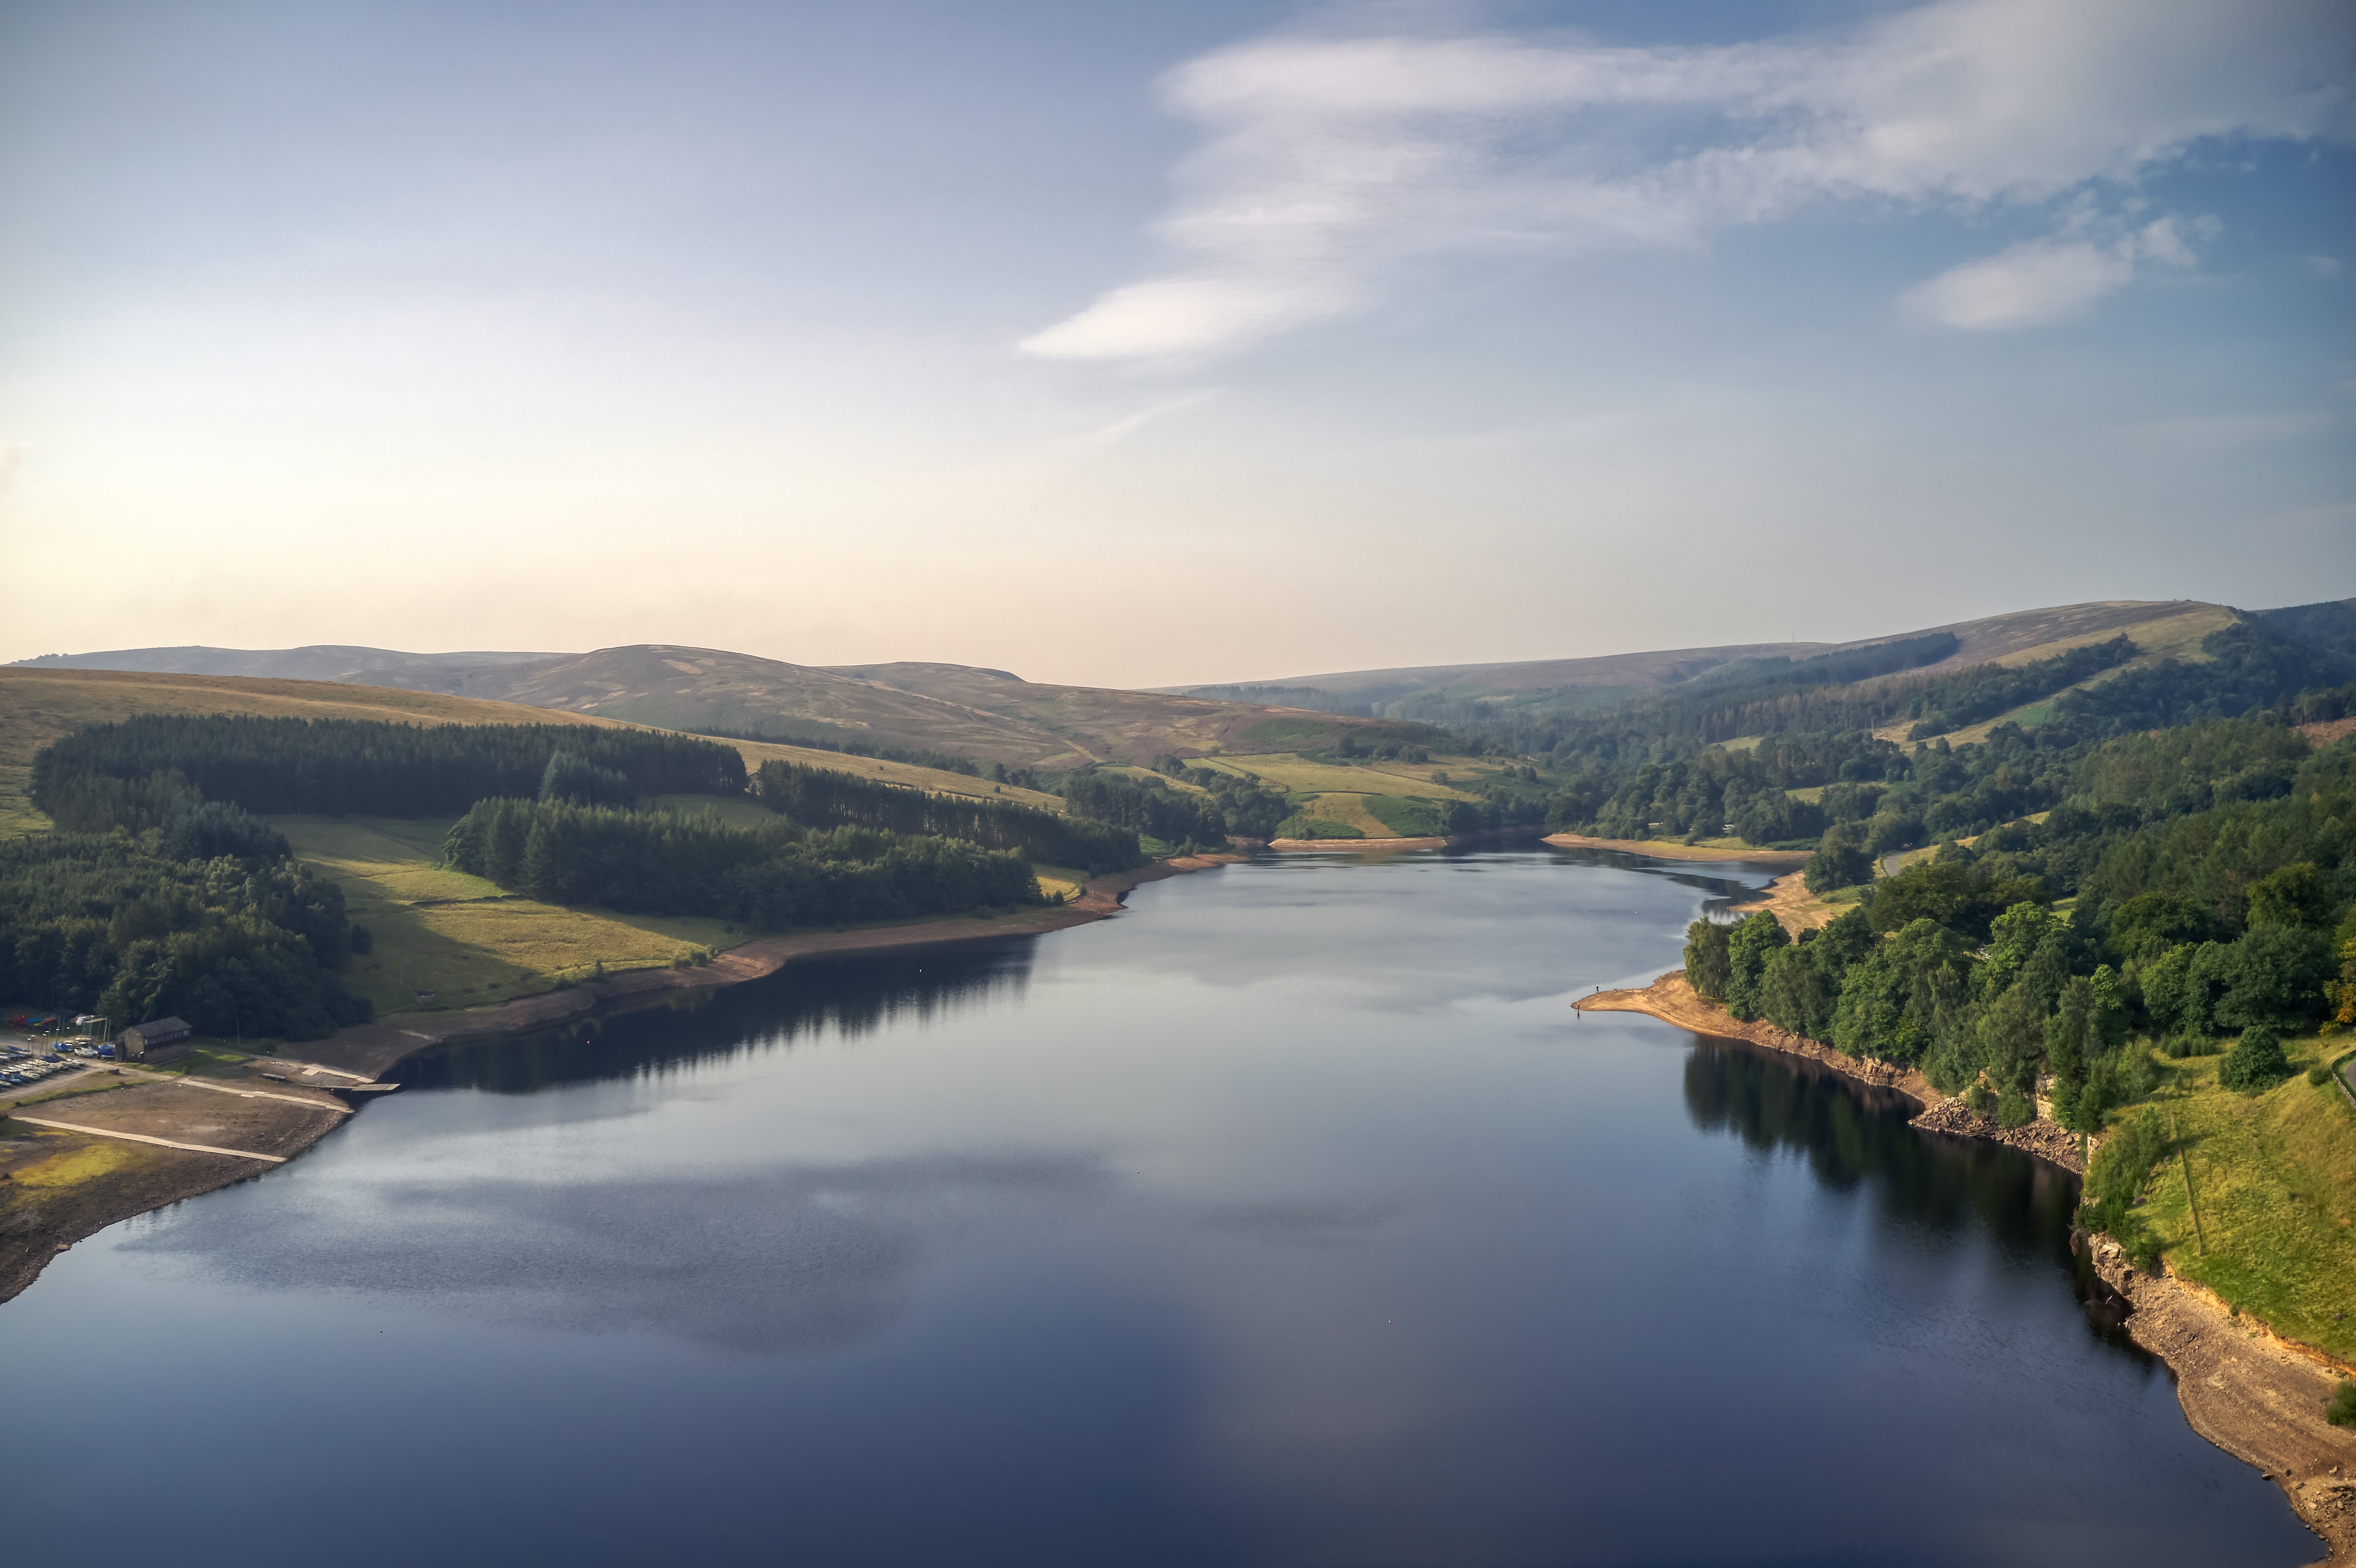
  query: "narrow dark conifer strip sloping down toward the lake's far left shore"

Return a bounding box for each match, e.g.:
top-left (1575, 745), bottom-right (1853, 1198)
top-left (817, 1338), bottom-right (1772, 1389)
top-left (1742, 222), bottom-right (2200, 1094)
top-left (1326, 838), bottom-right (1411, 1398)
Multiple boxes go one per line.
top-left (754, 758), bottom-right (1145, 876)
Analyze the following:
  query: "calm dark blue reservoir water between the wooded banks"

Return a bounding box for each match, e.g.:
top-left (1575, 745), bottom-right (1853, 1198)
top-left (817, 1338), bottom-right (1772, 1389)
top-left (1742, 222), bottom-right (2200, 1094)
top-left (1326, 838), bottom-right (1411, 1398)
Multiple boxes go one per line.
top-left (0, 850), bottom-right (2316, 1568)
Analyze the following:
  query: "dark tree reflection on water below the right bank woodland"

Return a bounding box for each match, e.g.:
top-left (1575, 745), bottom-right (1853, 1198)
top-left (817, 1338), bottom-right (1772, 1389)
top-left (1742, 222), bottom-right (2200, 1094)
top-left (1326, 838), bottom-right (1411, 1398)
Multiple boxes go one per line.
top-left (1685, 1034), bottom-right (2151, 1361)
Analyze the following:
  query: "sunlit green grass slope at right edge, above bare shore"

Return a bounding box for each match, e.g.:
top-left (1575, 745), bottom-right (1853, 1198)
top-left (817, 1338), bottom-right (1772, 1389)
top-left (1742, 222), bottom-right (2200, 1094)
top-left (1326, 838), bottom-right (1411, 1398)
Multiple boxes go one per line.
top-left (2125, 1036), bottom-right (2356, 1361)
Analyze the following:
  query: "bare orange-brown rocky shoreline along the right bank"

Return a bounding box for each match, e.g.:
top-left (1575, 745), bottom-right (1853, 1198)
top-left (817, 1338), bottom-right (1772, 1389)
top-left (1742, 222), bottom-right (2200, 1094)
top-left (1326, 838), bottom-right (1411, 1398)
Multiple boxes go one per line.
top-left (1571, 970), bottom-right (2356, 1568)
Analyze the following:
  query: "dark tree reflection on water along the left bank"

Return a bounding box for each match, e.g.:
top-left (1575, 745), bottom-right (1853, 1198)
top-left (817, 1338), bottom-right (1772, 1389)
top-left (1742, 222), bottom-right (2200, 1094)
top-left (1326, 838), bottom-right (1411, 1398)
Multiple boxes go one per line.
top-left (387, 937), bottom-right (1037, 1095)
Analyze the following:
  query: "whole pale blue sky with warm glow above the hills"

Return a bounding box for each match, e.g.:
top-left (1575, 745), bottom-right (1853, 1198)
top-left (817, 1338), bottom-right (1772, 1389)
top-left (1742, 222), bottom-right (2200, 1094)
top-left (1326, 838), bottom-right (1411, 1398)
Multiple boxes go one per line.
top-left (0, 0), bottom-right (2356, 685)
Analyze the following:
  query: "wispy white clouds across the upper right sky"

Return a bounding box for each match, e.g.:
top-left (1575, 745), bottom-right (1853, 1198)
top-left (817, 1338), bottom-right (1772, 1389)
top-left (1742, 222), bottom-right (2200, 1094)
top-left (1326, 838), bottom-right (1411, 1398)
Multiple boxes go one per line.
top-left (1022, 0), bottom-right (2356, 360)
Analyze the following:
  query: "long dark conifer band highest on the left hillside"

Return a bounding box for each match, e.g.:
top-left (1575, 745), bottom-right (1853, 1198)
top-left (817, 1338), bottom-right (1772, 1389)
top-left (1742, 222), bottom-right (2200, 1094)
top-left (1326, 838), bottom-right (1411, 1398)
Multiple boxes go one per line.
top-left (33, 713), bottom-right (745, 831)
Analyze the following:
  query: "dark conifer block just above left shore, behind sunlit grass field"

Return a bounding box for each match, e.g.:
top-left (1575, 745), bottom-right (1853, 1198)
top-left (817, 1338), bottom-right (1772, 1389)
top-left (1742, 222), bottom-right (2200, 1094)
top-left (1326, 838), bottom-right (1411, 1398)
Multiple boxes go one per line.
top-left (443, 798), bottom-right (1041, 930)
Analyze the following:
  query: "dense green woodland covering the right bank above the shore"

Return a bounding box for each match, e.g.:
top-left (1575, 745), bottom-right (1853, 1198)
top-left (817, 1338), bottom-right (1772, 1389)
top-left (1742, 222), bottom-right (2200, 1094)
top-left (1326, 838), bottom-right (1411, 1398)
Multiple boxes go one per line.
top-left (1687, 720), bottom-right (2356, 1172)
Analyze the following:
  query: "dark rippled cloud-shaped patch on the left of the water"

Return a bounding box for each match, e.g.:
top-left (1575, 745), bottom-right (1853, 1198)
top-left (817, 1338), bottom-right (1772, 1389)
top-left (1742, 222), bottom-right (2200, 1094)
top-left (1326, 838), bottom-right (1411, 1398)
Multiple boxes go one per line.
top-left (127, 1151), bottom-right (1112, 1354)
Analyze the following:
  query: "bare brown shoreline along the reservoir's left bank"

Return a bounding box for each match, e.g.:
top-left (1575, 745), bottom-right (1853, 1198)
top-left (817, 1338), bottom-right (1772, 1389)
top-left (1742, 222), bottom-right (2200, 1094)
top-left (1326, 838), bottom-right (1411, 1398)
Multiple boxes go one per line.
top-left (0, 852), bottom-right (1249, 1304)
